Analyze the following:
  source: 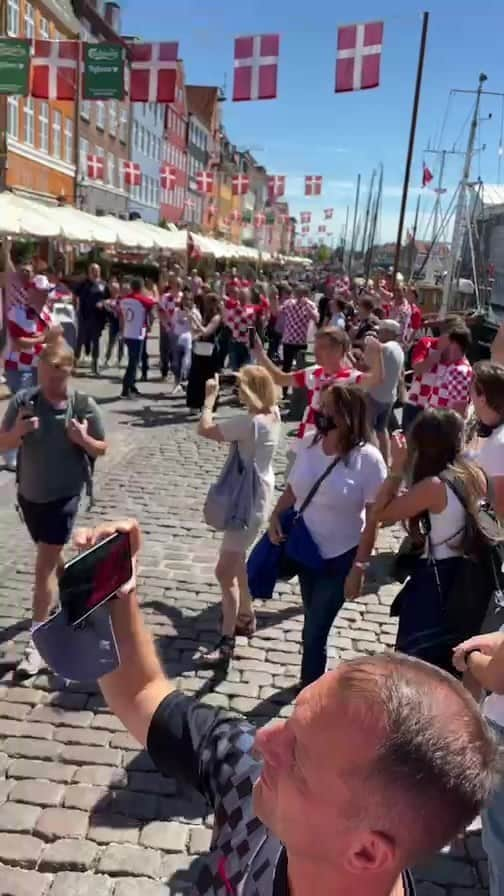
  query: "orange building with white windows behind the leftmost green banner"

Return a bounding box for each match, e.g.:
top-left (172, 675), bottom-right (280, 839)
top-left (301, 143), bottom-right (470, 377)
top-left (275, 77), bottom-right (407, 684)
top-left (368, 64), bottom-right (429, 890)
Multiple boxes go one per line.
top-left (0, 0), bottom-right (79, 203)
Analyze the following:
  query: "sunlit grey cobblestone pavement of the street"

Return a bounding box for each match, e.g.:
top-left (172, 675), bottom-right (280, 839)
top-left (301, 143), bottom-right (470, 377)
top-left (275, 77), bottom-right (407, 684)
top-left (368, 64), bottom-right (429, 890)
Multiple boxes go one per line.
top-left (0, 354), bottom-right (488, 896)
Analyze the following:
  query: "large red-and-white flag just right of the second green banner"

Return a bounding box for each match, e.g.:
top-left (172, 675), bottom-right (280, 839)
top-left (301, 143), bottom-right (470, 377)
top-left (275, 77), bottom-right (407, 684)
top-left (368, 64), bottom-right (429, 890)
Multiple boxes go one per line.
top-left (128, 42), bottom-right (178, 103)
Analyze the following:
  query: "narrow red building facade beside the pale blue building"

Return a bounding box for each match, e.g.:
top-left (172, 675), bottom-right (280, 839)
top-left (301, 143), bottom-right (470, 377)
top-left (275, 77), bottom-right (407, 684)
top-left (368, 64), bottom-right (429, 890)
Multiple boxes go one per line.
top-left (160, 61), bottom-right (188, 224)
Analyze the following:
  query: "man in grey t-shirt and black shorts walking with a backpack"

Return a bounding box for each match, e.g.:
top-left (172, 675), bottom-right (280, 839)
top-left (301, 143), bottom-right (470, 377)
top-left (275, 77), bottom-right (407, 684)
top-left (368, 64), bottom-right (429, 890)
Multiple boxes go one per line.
top-left (0, 336), bottom-right (107, 678)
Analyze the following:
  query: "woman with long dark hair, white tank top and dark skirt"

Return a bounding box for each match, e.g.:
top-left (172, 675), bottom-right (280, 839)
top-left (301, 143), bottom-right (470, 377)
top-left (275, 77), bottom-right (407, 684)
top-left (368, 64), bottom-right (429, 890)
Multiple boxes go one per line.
top-left (375, 409), bottom-right (486, 674)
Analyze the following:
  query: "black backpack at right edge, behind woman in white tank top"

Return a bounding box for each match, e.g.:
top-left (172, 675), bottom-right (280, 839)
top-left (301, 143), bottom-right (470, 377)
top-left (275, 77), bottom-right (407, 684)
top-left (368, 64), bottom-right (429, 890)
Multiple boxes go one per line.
top-left (440, 474), bottom-right (504, 641)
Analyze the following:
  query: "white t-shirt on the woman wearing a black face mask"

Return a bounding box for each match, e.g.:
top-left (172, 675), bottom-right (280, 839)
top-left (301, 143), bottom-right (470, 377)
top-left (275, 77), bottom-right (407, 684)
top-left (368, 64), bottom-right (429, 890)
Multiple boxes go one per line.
top-left (289, 434), bottom-right (387, 559)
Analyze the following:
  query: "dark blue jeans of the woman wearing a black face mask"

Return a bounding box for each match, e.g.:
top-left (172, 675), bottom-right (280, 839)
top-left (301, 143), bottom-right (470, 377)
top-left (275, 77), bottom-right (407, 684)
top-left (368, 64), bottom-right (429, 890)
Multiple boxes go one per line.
top-left (299, 547), bottom-right (357, 687)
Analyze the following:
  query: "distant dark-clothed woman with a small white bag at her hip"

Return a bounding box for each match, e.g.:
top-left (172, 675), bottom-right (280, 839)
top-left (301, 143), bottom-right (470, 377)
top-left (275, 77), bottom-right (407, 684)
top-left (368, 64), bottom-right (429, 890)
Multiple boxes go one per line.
top-left (187, 293), bottom-right (222, 411)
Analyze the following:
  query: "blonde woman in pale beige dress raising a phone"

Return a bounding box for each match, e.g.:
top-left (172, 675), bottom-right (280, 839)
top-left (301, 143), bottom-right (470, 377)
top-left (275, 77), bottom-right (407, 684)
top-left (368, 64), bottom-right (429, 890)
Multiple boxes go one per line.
top-left (198, 365), bottom-right (281, 667)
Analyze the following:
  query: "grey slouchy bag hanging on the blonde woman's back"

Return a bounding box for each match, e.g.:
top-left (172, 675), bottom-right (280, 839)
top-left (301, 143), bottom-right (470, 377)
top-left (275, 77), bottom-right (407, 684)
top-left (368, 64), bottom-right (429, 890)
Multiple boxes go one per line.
top-left (203, 420), bottom-right (260, 532)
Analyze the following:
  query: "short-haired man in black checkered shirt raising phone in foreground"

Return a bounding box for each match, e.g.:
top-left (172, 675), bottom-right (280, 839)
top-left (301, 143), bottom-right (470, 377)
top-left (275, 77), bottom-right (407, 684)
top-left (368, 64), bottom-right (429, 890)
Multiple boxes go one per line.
top-left (73, 521), bottom-right (497, 896)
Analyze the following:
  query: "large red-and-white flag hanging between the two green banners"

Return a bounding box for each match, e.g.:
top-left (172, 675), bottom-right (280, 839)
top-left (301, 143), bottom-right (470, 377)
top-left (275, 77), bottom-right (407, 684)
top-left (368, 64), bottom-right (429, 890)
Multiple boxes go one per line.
top-left (30, 40), bottom-right (80, 100)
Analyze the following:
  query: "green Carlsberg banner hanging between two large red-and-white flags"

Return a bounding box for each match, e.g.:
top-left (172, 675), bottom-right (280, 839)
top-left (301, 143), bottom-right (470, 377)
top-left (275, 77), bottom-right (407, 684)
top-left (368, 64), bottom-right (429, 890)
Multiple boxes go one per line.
top-left (82, 44), bottom-right (124, 100)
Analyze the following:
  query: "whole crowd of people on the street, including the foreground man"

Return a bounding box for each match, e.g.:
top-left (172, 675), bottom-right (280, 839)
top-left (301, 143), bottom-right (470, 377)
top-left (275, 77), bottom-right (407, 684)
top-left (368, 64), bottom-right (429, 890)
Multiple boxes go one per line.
top-left (0, 240), bottom-right (504, 896)
